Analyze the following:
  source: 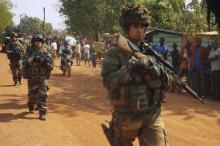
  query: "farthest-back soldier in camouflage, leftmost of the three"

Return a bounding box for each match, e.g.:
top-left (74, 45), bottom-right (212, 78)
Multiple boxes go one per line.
top-left (6, 32), bottom-right (24, 86)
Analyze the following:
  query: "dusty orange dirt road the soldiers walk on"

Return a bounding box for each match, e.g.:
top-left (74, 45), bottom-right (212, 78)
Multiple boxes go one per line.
top-left (0, 54), bottom-right (220, 146)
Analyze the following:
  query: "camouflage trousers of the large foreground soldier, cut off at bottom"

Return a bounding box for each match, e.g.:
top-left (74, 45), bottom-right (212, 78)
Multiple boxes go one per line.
top-left (111, 108), bottom-right (168, 146)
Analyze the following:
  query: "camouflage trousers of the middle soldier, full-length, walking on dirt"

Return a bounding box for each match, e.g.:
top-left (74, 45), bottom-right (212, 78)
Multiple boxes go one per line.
top-left (27, 77), bottom-right (49, 112)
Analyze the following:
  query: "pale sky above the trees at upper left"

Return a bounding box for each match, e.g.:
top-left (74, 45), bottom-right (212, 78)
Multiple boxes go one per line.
top-left (11, 0), bottom-right (65, 29)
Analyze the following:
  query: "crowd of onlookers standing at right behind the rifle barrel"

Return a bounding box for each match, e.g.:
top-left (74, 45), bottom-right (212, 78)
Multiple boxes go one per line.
top-left (154, 38), bottom-right (220, 100)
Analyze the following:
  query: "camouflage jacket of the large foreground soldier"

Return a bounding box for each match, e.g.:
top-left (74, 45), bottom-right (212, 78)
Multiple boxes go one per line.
top-left (102, 46), bottom-right (174, 110)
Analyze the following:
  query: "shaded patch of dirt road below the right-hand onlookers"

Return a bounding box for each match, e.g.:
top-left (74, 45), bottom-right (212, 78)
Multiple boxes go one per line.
top-left (163, 93), bottom-right (220, 120)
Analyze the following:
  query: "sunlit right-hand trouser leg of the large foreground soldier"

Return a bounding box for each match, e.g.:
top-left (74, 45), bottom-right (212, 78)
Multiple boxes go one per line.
top-left (138, 112), bottom-right (168, 146)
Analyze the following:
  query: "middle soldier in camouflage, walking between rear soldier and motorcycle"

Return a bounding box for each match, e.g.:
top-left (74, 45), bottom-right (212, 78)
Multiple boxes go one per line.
top-left (23, 34), bottom-right (53, 120)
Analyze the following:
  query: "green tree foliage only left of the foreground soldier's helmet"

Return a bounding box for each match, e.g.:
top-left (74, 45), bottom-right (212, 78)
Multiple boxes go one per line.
top-left (60, 0), bottom-right (133, 39)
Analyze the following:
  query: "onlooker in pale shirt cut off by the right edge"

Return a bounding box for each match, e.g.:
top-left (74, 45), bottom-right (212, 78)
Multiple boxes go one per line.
top-left (208, 40), bottom-right (220, 100)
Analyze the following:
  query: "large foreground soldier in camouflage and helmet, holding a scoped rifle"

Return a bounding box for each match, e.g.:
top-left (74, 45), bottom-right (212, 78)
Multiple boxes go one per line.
top-left (102, 5), bottom-right (172, 146)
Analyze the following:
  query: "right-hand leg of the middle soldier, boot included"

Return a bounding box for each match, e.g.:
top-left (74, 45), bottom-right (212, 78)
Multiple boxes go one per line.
top-left (38, 81), bottom-right (48, 120)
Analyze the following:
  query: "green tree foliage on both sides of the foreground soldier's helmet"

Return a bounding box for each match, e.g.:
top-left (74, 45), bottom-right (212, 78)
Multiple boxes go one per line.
top-left (60, 0), bottom-right (214, 38)
